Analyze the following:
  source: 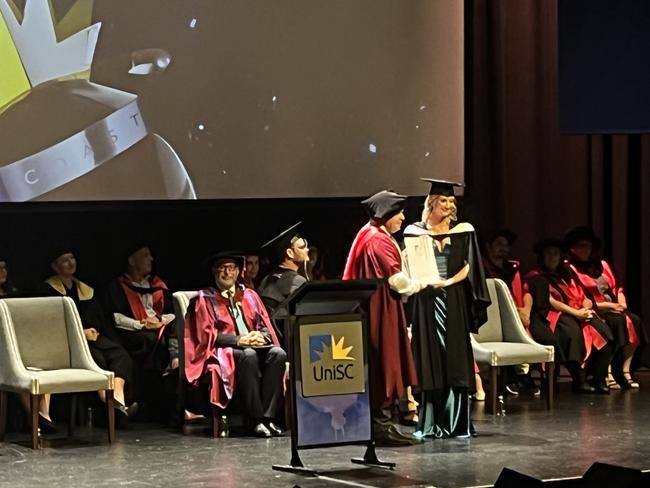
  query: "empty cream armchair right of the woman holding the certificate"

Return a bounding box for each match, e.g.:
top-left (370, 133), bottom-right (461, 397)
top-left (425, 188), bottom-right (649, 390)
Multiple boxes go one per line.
top-left (472, 278), bottom-right (554, 413)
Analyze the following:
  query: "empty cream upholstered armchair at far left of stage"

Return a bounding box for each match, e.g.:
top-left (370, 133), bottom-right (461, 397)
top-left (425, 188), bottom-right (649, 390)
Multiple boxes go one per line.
top-left (0, 297), bottom-right (115, 449)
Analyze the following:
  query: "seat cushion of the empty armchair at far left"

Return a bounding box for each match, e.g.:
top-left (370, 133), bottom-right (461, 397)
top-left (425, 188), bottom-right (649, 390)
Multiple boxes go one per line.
top-left (28, 369), bottom-right (111, 395)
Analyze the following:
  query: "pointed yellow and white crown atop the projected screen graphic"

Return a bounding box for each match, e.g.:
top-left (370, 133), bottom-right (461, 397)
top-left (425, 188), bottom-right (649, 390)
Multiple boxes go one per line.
top-left (0, 0), bottom-right (101, 108)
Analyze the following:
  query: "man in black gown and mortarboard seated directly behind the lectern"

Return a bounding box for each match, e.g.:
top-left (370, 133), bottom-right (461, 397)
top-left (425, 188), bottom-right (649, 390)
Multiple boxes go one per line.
top-left (257, 222), bottom-right (309, 343)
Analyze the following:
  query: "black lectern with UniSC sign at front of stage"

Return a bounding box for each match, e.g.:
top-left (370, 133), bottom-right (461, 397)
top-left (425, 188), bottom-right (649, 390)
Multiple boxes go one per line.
top-left (273, 280), bottom-right (395, 476)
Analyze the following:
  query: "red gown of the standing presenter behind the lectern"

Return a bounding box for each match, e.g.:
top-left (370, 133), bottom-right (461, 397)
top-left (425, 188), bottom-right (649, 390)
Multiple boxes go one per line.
top-left (343, 223), bottom-right (417, 415)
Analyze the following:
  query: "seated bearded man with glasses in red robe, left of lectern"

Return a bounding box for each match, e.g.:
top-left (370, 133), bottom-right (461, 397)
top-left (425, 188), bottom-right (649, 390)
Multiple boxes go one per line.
top-left (185, 252), bottom-right (287, 437)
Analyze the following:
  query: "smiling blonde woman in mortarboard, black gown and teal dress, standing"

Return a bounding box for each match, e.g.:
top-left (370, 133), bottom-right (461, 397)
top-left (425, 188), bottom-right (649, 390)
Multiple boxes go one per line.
top-left (404, 179), bottom-right (490, 438)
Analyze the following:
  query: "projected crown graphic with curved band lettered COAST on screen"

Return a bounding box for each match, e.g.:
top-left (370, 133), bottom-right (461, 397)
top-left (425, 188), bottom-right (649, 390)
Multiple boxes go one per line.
top-left (0, 0), bottom-right (196, 202)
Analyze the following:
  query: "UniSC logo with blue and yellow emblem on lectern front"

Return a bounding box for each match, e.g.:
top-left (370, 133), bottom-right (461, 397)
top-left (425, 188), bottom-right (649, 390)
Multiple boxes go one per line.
top-left (309, 335), bottom-right (355, 383)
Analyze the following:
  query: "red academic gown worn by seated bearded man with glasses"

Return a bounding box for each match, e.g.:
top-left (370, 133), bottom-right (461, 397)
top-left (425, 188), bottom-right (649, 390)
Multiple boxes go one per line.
top-left (185, 287), bottom-right (279, 408)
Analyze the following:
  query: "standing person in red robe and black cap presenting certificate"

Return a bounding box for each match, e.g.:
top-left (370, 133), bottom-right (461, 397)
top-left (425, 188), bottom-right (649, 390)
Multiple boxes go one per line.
top-left (343, 190), bottom-right (426, 446)
